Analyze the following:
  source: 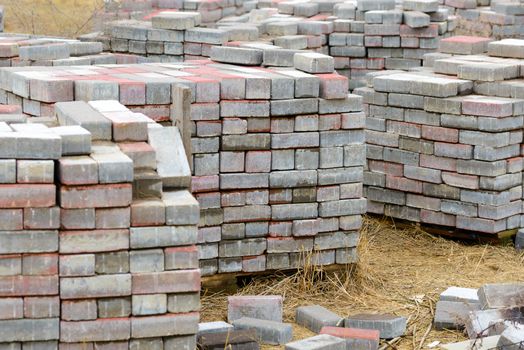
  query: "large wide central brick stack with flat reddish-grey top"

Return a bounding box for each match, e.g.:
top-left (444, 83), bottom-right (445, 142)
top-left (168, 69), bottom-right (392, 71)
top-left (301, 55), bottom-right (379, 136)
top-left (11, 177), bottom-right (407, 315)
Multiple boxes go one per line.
top-left (0, 54), bottom-right (365, 274)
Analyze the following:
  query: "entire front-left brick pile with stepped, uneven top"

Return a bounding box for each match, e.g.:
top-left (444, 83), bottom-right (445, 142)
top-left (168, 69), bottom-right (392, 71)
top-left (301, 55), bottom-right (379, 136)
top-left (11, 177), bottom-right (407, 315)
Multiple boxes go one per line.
top-left (0, 101), bottom-right (200, 349)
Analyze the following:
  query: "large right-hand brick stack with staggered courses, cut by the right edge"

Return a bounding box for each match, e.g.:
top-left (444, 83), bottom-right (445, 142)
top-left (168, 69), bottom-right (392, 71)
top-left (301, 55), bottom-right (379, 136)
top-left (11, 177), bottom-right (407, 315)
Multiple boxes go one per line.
top-left (355, 37), bottom-right (524, 236)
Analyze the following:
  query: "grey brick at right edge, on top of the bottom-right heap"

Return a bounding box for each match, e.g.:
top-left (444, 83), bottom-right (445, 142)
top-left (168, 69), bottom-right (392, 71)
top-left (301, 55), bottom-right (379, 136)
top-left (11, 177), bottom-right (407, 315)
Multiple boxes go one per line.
top-left (478, 283), bottom-right (524, 309)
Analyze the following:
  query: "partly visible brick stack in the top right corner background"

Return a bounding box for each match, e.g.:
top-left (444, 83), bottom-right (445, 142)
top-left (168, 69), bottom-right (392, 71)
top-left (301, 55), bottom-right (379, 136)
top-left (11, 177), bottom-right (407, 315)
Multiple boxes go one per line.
top-left (446, 0), bottom-right (524, 39)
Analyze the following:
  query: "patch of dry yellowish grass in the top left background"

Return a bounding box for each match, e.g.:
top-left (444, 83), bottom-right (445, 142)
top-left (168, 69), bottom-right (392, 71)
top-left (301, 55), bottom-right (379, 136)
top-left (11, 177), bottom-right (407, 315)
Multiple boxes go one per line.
top-left (0, 0), bottom-right (103, 37)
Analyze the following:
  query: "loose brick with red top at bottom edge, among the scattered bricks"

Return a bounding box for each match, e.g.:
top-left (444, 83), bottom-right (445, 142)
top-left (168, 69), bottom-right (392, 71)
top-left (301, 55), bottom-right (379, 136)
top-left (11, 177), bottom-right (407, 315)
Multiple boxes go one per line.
top-left (320, 326), bottom-right (380, 350)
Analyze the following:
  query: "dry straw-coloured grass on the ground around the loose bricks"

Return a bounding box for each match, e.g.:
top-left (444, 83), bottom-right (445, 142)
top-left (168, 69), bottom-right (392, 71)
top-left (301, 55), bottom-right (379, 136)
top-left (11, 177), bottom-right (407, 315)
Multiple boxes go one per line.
top-left (202, 218), bottom-right (524, 349)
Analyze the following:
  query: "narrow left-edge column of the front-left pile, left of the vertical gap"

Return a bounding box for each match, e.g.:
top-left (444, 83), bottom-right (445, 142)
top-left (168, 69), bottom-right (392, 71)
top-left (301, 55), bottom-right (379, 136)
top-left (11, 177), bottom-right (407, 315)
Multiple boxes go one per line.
top-left (0, 123), bottom-right (61, 348)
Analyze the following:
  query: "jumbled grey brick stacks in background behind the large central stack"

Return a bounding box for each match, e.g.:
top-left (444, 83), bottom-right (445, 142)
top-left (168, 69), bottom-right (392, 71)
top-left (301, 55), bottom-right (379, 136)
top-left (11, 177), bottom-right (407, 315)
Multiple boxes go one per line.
top-left (86, 0), bottom-right (455, 76)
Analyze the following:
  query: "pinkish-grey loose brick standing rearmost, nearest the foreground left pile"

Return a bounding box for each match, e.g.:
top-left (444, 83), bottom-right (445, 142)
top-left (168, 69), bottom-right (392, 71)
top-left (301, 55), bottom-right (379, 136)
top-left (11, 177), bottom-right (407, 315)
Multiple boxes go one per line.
top-left (227, 295), bottom-right (282, 322)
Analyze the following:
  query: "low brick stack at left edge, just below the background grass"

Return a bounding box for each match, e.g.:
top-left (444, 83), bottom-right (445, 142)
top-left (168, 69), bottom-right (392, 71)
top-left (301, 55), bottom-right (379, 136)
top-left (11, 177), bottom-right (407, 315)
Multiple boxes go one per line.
top-left (0, 34), bottom-right (146, 67)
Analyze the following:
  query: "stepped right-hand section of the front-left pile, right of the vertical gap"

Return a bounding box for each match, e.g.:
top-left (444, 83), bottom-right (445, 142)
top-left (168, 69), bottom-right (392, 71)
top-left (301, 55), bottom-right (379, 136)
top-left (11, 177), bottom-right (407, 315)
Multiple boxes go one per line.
top-left (57, 101), bottom-right (200, 349)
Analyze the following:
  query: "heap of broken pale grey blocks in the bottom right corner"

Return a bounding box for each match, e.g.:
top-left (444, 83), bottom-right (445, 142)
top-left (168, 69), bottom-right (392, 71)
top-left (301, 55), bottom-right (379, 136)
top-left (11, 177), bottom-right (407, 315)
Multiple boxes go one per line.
top-left (435, 283), bottom-right (524, 349)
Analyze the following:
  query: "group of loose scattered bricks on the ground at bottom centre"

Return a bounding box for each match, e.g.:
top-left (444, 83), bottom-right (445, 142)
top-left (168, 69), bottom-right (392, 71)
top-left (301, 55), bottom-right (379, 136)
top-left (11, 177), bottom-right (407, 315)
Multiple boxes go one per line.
top-left (198, 295), bottom-right (406, 350)
